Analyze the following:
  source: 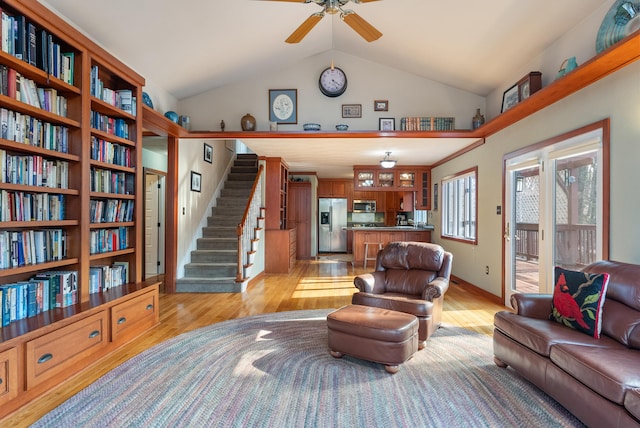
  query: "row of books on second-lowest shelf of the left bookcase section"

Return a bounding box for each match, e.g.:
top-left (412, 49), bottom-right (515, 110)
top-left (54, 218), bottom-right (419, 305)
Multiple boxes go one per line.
top-left (0, 229), bottom-right (67, 269)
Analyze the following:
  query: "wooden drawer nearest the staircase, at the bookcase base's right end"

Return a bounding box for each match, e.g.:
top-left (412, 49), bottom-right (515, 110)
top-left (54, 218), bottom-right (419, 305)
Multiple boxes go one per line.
top-left (111, 290), bottom-right (159, 342)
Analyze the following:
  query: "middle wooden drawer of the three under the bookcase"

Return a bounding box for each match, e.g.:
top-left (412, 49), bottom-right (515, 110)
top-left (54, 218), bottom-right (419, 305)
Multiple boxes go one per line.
top-left (26, 311), bottom-right (108, 389)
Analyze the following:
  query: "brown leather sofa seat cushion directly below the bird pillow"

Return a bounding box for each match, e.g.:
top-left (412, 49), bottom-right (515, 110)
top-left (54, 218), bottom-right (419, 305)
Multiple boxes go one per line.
top-left (493, 311), bottom-right (596, 357)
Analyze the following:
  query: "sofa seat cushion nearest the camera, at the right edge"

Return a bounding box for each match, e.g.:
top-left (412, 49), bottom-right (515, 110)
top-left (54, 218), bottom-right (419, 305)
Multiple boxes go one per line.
top-left (550, 337), bottom-right (640, 405)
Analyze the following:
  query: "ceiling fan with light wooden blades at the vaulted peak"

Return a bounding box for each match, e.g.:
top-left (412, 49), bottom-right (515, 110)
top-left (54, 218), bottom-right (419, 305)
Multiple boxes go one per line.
top-left (262, 0), bottom-right (382, 43)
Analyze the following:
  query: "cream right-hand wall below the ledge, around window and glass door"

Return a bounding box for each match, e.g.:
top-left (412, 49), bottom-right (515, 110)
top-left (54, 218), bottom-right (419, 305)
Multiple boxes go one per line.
top-left (432, 62), bottom-right (640, 296)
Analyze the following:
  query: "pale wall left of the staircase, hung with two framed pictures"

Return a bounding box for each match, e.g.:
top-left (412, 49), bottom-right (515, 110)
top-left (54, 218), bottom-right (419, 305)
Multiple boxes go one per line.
top-left (177, 139), bottom-right (235, 278)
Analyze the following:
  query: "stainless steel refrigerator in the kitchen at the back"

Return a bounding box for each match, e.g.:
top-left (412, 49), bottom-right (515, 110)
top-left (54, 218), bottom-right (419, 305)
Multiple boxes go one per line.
top-left (318, 198), bottom-right (347, 253)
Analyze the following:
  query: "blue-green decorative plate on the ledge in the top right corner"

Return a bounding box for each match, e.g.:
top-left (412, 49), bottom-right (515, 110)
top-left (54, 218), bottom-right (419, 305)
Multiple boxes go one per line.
top-left (596, 0), bottom-right (640, 53)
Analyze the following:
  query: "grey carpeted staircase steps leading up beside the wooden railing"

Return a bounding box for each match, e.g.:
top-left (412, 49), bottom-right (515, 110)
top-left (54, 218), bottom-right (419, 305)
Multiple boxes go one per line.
top-left (176, 154), bottom-right (258, 293)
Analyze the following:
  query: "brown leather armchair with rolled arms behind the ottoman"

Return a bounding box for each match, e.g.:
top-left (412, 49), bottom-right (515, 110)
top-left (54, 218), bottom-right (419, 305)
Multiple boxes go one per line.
top-left (351, 242), bottom-right (453, 349)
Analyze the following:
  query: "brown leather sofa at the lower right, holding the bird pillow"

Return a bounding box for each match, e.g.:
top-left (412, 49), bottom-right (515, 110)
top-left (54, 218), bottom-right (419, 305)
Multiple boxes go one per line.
top-left (493, 261), bottom-right (640, 427)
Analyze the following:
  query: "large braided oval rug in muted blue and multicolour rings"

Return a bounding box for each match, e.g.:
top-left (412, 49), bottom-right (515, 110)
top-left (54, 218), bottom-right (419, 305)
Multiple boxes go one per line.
top-left (34, 309), bottom-right (582, 428)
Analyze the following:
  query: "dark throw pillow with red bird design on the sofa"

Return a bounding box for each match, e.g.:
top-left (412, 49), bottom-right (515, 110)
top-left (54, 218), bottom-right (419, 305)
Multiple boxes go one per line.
top-left (550, 266), bottom-right (609, 339)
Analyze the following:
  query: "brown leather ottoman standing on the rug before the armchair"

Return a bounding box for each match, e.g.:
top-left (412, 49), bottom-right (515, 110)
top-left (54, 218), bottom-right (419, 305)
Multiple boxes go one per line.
top-left (327, 305), bottom-right (418, 374)
